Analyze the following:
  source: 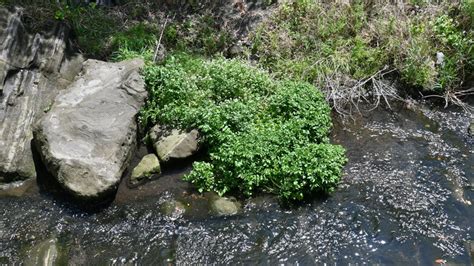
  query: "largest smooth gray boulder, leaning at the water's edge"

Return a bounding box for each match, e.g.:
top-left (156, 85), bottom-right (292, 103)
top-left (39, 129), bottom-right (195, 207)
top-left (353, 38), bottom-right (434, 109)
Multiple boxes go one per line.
top-left (34, 59), bottom-right (147, 199)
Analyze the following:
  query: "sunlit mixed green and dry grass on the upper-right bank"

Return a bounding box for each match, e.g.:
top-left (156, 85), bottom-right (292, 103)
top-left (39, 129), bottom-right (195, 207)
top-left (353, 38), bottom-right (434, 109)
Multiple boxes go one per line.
top-left (249, 0), bottom-right (474, 93)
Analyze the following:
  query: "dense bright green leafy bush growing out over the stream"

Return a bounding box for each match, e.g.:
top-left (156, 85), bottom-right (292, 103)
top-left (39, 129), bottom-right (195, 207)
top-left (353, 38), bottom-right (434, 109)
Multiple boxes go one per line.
top-left (140, 54), bottom-right (346, 200)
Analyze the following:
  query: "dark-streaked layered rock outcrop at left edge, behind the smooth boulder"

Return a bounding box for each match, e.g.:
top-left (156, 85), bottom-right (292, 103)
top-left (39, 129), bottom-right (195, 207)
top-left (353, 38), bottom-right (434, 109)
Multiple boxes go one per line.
top-left (0, 8), bottom-right (83, 183)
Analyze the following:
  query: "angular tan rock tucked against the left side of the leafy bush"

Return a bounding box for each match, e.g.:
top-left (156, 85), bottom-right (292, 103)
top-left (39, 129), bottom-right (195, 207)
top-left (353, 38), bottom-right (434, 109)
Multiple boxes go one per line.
top-left (150, 125), bottom-right (199, 162)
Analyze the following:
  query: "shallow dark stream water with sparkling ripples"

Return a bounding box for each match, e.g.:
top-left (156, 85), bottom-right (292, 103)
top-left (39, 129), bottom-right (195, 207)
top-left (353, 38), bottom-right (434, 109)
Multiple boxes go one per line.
top-left (0, 101), bottom-right (474, 265)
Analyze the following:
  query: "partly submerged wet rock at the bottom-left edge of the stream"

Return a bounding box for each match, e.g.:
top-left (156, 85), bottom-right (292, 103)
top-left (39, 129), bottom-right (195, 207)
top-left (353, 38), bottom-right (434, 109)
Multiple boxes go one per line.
top-left (25, 239), bottom-right (59, 266)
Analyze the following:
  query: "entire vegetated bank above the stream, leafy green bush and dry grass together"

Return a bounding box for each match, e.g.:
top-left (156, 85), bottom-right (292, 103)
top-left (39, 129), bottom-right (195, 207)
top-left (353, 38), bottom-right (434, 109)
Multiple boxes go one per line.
top-left (1, 0), bottom-right (474, 201)
